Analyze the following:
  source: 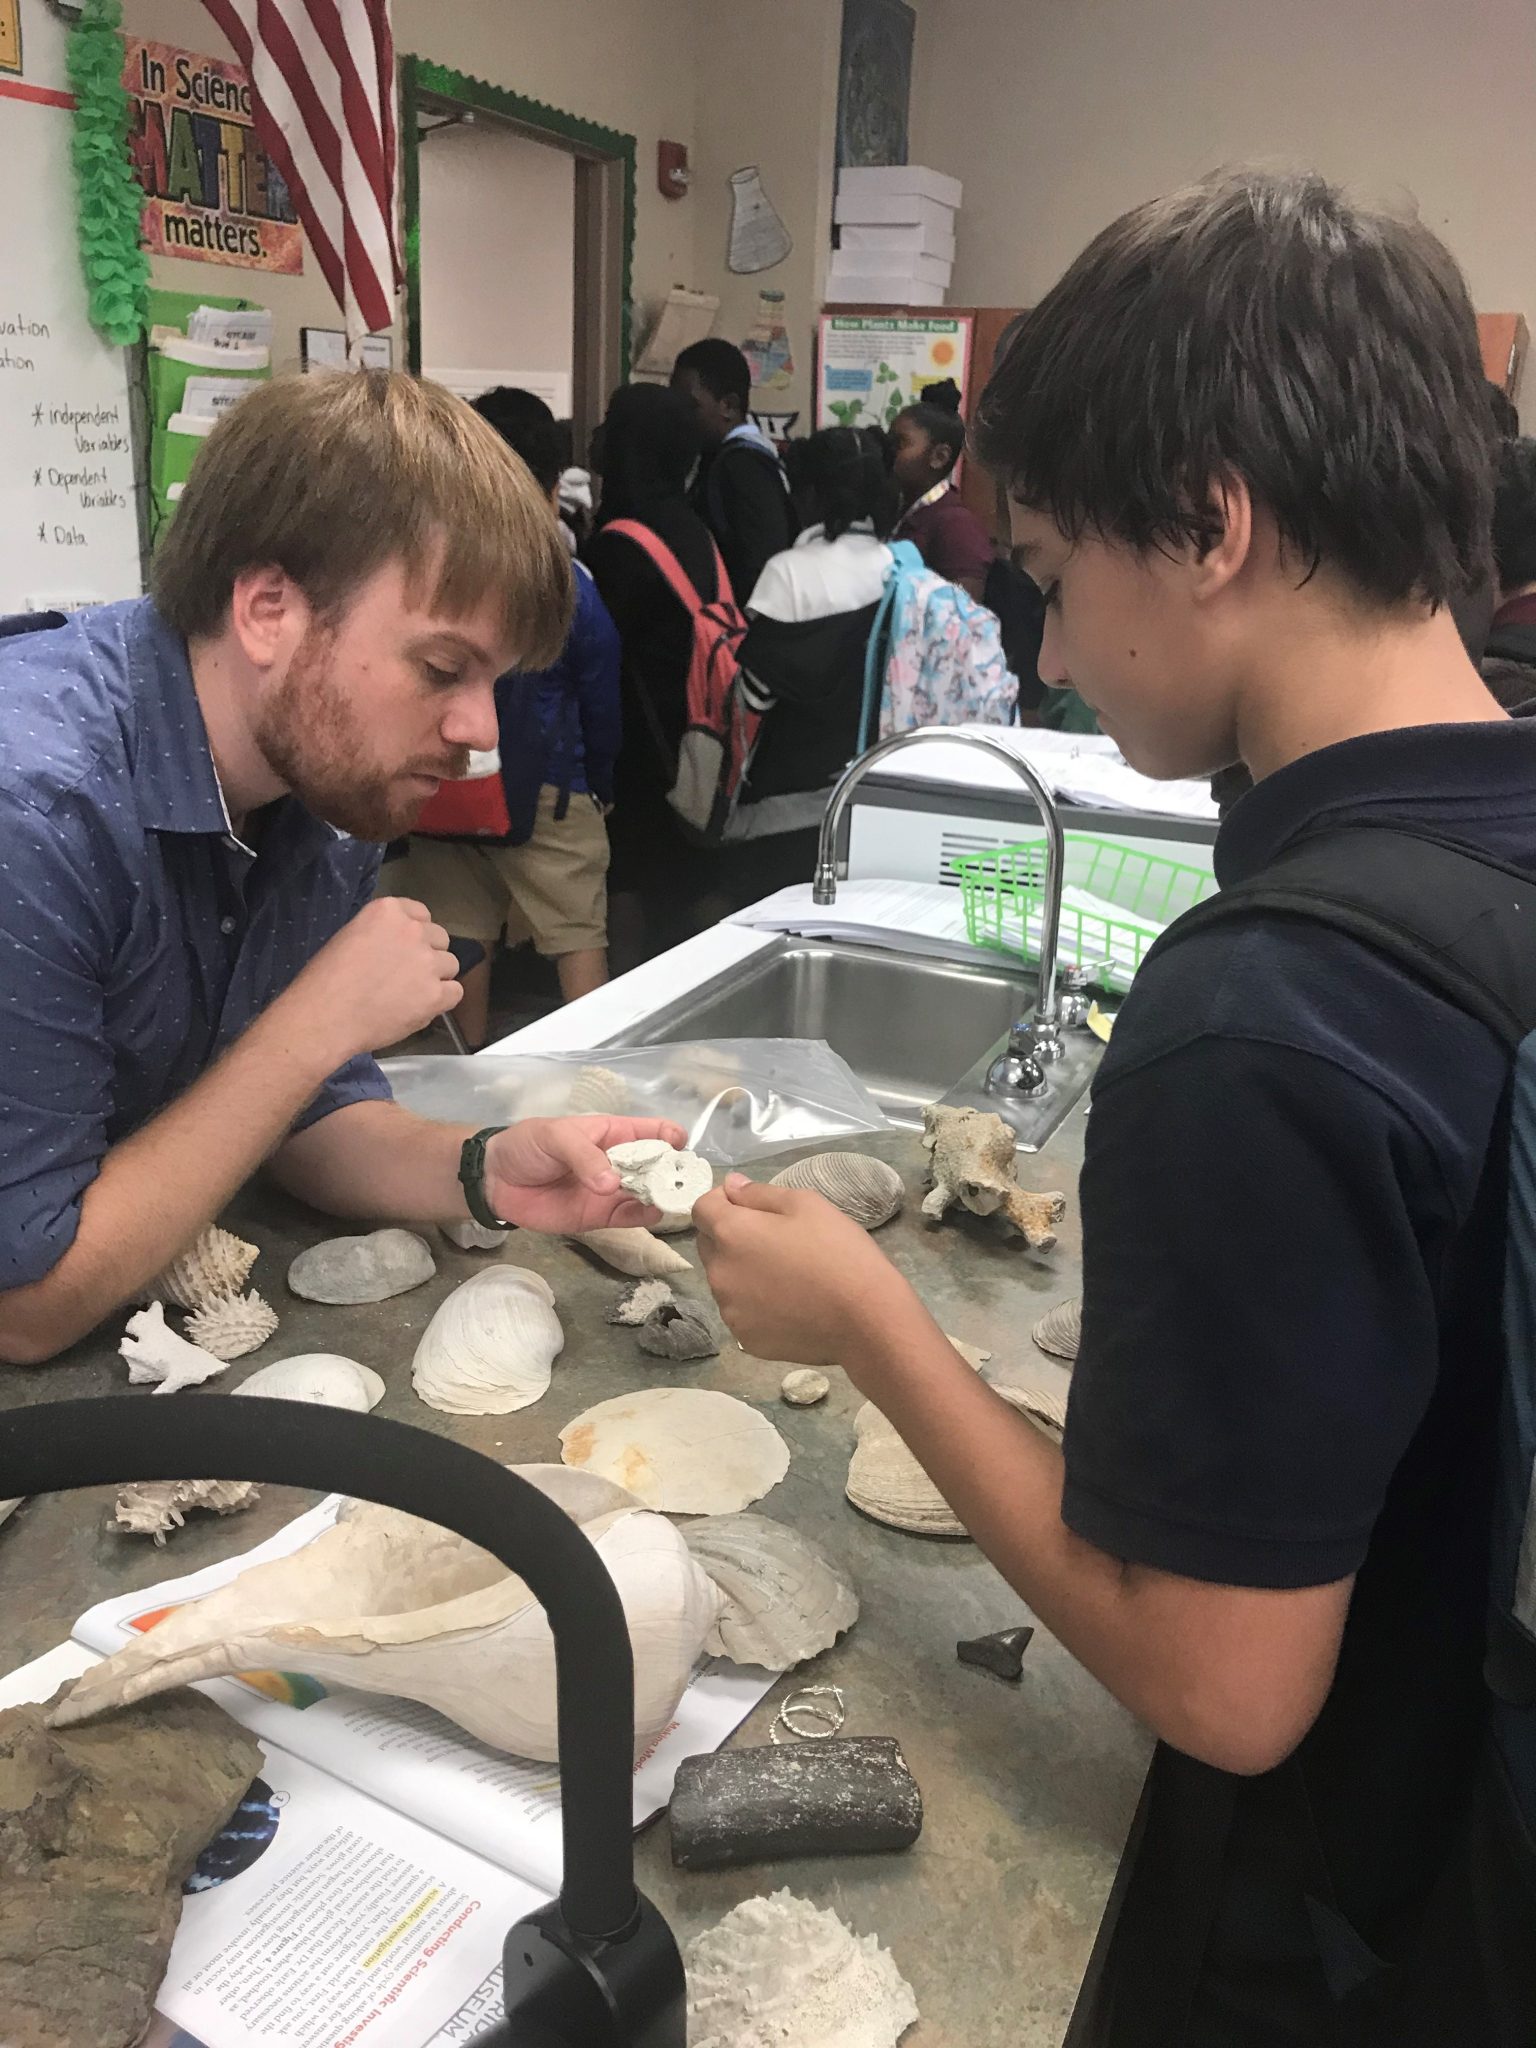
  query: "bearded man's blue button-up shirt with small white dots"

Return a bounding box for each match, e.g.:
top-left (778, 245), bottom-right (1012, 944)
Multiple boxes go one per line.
top-left (0, 598), bottom-right (389, 1288)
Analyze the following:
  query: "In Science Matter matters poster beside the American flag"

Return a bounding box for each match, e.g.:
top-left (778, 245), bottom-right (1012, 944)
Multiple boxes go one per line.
top-left (123, 35), bottom-right (303, 276)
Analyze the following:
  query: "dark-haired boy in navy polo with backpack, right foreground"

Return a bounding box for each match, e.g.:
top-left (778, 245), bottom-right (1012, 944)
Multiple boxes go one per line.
top-left (696, 172), bottom-right (1536, 2048)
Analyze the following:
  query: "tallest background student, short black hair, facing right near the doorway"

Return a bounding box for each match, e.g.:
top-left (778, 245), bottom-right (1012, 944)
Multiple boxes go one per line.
top-left (672, 336), bottom-right (795, 600)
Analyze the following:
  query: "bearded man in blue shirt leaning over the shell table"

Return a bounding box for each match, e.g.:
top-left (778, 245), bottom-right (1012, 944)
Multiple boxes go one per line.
top-left (0, 373), bottom-right (682, 1364)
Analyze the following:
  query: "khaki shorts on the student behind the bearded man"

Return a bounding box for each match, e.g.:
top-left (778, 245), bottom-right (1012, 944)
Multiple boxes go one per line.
top-left (377, 784), bottom-right (608, 961)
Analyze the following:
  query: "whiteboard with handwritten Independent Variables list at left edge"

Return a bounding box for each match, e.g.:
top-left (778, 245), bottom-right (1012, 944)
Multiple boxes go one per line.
top-left (0, 0), bottom-right (143, 612)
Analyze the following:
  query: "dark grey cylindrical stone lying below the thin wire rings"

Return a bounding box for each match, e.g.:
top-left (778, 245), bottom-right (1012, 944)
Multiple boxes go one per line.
top-left (672, 1735), bottom-right (924, 1870)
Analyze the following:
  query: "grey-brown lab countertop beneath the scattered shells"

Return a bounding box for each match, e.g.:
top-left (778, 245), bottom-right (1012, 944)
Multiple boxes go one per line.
top-left (0, 1122), bottom-right (1149, 2048)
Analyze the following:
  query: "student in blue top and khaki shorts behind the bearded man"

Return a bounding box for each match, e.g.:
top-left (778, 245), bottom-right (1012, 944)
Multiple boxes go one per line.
top-left (379, 385), bottom-right (618, 1047)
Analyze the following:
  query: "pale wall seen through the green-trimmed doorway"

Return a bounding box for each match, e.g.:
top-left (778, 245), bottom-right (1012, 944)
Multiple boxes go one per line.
top-left (420, 123), bottom-right (575, 391)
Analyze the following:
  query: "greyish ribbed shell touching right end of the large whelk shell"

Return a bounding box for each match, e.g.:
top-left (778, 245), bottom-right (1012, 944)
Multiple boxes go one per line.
top-left (682, 1516), bottom-right (858, 1671)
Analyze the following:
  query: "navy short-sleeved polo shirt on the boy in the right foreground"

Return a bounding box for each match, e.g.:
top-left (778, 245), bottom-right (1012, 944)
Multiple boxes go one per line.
top-left (1063, 721), bottom-right (1536, 2007)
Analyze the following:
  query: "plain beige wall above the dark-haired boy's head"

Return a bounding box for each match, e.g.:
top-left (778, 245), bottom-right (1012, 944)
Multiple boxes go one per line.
top-left (911, 0), bottom-right (1536, 420)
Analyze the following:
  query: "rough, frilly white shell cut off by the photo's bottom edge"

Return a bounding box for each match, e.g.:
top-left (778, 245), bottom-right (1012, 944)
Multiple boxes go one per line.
top-left (684, 1890), bottom-right (918, 2048)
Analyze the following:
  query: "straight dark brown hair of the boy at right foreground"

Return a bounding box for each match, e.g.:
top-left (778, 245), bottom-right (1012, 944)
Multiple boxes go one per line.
top-left (975, 170), bottom-right (1493, 606)
